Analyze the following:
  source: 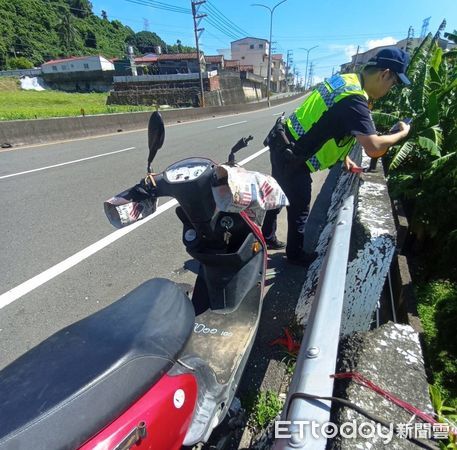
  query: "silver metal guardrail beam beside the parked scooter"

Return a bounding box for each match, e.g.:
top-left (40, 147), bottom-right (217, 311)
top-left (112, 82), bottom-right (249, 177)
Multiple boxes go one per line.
top-left (273, 195), bottom-right (354, 450)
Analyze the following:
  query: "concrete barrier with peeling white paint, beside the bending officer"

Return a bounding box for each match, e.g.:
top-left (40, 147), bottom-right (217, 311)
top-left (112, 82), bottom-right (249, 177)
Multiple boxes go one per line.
top-left (295, 145), bottom-right (396, 335)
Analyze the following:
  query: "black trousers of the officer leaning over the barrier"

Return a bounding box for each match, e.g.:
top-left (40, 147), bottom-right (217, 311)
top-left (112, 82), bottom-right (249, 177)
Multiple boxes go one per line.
top-left (262, 145), bottom-right (312, 259)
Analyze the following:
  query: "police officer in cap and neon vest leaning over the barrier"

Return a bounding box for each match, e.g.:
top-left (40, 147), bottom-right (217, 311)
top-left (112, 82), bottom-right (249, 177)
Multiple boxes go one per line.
top-left (262, 47), bottom-right (410, 266)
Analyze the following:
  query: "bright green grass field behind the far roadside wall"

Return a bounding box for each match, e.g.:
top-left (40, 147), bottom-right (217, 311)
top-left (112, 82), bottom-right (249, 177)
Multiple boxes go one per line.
top-left (0, 89), bottom-right (159, 120)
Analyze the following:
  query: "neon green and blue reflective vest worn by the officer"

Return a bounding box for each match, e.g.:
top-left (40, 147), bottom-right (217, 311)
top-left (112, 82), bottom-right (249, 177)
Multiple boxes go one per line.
top-left (286, 73), bottom-right (368, 172)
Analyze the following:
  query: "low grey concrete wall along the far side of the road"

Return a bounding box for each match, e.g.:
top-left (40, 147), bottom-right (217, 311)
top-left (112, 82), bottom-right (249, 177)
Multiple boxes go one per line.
top-left (0, 93), bottom-right (303, 147)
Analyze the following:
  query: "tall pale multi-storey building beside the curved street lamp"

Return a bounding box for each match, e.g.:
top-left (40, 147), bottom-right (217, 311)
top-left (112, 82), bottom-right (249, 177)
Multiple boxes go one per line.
top-left (230, 37), bottom-right (270, 78)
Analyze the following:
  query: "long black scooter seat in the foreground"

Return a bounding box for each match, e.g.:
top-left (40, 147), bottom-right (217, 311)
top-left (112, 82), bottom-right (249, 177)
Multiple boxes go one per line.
top-left (0, 279), bottom-right (195, 450)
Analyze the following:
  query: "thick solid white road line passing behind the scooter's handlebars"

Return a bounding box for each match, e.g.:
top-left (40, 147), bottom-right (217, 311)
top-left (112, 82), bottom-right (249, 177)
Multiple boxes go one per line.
top-left (0, 147), bottom-right (268, 309)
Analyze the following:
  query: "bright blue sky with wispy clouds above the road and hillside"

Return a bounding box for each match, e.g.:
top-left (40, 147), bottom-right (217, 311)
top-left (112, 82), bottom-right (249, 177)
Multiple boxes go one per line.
top-left (91, 0), bottom-right (457, 80)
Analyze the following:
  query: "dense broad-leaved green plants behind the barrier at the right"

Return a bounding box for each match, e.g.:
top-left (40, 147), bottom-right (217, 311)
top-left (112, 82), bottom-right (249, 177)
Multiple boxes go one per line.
top-left (374, 21), bottom-right (457, 438)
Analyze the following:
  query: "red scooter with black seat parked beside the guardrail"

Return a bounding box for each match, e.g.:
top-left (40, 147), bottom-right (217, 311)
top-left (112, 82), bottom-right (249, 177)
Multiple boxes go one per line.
top-left (0, 113), bottom-right (283, 450)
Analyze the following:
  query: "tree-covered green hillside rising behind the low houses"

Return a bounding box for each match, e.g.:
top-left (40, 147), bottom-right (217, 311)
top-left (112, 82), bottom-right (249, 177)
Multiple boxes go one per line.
top-left (0, 0), bottom-right (193, 70)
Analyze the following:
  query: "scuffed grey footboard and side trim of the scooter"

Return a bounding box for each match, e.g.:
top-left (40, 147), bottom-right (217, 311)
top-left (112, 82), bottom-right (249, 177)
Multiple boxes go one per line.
top-left (175, 213), bottom-right (267, 446)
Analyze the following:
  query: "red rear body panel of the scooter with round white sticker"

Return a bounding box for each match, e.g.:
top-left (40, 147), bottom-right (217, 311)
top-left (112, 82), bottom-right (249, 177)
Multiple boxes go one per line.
top-left (80, 374), bottom-right (197, 450)
